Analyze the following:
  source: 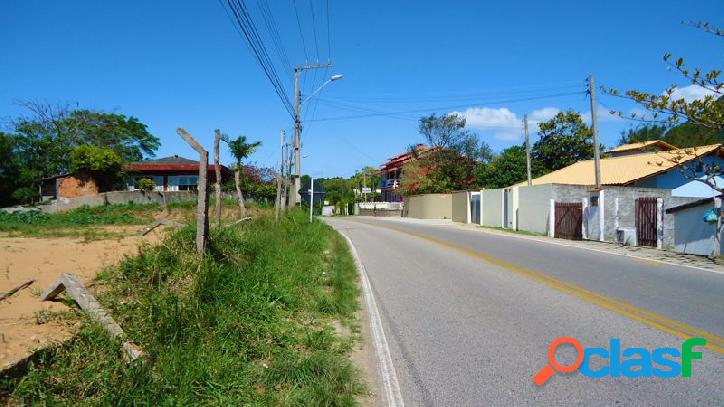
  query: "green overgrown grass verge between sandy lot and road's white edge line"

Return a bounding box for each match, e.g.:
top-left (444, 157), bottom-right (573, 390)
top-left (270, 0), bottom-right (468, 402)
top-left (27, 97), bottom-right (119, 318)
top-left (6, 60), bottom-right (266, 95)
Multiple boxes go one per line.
top-left (0, 211), bottom-right (365, 406)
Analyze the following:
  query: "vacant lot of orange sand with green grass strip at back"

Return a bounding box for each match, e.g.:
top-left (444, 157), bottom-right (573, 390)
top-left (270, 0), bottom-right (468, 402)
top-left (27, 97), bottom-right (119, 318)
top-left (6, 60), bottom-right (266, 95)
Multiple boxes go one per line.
top-left (0, 201), bottom-right (258, 370)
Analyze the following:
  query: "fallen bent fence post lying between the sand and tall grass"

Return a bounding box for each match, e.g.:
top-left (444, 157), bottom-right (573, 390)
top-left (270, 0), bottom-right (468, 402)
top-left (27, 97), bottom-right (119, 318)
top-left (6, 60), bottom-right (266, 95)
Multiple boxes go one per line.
top-left (40, 273), bottom-right (145, 361)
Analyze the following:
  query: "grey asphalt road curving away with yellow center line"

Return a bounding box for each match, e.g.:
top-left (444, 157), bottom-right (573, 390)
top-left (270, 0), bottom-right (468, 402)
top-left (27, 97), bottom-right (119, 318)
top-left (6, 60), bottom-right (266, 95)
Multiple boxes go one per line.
top-left (328, 218), bottom-right (724, 406)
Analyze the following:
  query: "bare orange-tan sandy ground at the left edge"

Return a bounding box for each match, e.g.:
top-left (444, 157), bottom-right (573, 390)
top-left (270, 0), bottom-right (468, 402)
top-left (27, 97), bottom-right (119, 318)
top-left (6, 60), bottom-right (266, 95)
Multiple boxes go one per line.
top-left (0, 226), bottom-right (165, 370)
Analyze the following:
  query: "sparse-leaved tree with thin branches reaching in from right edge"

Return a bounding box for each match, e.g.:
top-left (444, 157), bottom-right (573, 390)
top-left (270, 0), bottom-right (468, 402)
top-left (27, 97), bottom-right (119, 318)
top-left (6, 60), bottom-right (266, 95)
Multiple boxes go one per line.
top-left (602, 22), bottom-right (724, 256)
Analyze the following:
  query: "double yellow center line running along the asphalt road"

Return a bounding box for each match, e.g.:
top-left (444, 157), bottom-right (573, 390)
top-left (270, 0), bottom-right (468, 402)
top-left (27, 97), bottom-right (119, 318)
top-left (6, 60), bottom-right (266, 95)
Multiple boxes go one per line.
top-left (350, 218), bottom-right (724, 354)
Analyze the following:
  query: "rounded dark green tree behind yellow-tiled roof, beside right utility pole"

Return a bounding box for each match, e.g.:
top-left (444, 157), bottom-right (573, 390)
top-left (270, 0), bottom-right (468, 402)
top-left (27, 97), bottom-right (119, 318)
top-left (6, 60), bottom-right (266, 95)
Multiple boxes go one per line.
top-left (523, 110), bottom-right (593, 171)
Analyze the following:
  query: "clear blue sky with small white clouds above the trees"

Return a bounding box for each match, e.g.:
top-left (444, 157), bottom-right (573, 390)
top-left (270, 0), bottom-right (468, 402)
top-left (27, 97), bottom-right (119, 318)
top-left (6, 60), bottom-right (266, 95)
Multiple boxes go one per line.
top-left (0, 0), bottom-right (724, 177)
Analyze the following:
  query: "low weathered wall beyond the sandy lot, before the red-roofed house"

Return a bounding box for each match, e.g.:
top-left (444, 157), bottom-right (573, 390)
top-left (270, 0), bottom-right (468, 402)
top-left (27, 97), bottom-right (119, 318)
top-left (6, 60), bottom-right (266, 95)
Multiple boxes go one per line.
top-left (39, 191), bottom-right (196, 213)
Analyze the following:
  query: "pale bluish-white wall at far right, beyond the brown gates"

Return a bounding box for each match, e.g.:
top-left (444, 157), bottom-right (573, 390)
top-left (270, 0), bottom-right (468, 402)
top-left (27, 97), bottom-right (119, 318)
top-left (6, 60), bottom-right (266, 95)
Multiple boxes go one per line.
top-left (666, 202), bottom-right (724, 256)
